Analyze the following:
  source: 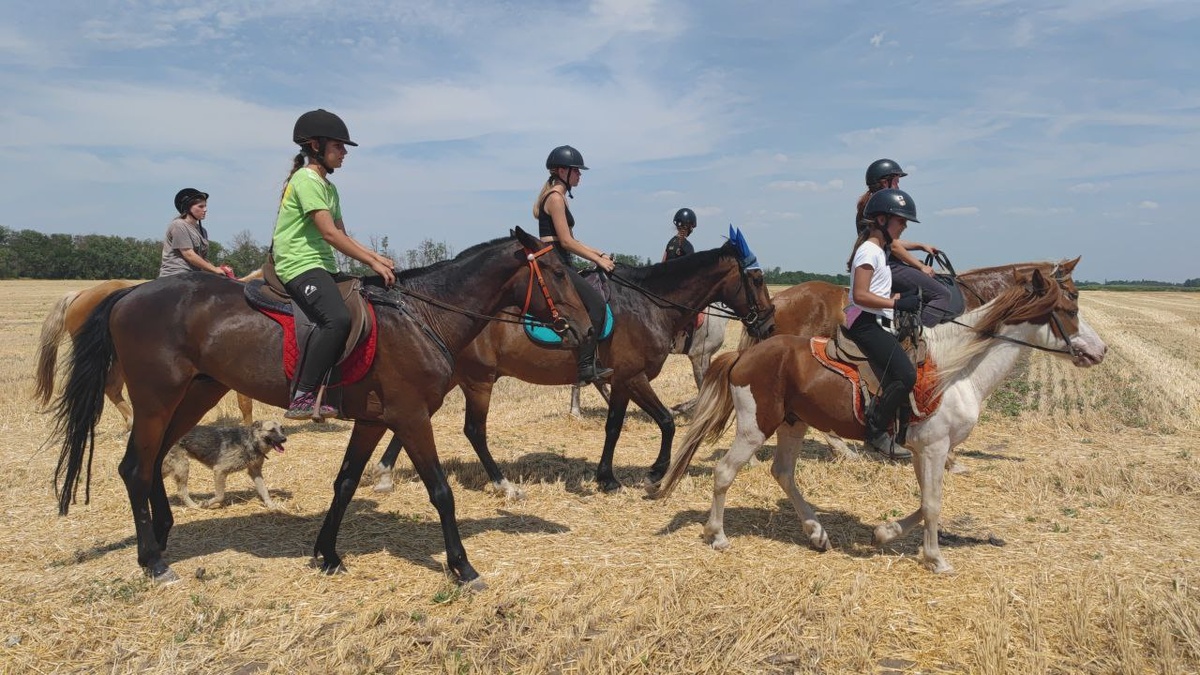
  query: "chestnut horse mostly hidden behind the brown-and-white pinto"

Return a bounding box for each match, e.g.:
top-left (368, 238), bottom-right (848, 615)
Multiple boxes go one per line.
top-left (738, 258), bottom-right (1079, 458)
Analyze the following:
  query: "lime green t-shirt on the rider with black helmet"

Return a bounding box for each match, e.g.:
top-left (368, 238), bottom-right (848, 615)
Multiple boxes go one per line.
top-left (271, 167), bottom-right (342, 283)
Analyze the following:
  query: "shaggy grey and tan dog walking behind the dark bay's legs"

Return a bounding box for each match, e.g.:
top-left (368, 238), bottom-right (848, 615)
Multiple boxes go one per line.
top-left (162, 422), bottom-right (288, 510)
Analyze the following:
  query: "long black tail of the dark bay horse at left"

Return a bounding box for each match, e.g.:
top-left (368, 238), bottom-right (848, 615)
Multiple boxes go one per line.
top-left (54, 288), bottom-right (132, 515)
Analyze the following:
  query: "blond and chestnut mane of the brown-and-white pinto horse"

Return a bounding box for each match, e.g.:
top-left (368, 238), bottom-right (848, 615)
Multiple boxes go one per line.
top-left (925, 275), bottom-right (1058, 393)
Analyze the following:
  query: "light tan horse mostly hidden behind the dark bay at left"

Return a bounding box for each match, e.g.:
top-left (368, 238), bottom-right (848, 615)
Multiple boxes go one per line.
top-left (34, 269), bottom-right (263, 425)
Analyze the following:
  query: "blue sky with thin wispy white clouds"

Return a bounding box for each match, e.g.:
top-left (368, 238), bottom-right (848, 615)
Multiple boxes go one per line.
top-left (0, 0), bottom-right (1200, 282)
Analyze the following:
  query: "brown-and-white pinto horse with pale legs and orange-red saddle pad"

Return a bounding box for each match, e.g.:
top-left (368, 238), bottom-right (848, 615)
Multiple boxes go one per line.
top-left (656, 263), bottom-right (1106, 572)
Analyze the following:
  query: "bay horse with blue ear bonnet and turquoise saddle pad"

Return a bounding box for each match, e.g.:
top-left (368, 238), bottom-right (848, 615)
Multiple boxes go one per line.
top-left (376, 236), bottom-right (774, 497)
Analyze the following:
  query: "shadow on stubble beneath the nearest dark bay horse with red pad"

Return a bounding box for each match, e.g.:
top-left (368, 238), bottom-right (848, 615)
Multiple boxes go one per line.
top-left (62, 498), bottom-right (570, 572)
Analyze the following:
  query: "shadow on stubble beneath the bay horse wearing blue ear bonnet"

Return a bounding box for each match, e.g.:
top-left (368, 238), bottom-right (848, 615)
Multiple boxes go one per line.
top-left (386, 452), bottom-right (649, 495)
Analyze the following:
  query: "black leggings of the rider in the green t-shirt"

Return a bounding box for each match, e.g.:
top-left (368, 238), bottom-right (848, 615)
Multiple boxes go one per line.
top-left (284, 263), bottom-right (350, 392)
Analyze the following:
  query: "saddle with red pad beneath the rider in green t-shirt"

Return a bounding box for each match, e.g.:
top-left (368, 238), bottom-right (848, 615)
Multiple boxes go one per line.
top-left (245, 256), bottom-right (376, 386)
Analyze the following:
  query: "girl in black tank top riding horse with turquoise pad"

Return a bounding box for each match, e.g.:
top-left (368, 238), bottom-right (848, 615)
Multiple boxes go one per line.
top-left (533, 145), bottom-right (613, 383)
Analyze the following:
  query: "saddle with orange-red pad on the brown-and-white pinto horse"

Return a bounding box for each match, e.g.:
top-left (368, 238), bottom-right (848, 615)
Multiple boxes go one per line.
top-left (809, 327), bottom-right (942, 424)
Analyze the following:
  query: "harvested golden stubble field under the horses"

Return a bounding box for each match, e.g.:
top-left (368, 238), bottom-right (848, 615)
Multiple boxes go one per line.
top-left (0, 281), bottom-right (1200, 674)
